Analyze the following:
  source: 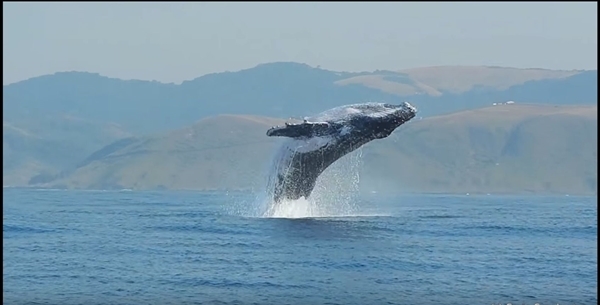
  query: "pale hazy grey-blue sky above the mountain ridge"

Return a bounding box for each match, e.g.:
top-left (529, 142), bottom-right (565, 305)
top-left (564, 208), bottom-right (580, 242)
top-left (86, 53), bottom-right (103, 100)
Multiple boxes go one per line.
top-left (2, 2), bottom-right (598, 84)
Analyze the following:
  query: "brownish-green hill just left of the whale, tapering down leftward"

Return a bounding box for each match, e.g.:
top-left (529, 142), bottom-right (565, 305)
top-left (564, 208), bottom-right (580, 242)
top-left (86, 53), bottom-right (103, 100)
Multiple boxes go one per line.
top-left (35, 115), bottom-right (284, 189)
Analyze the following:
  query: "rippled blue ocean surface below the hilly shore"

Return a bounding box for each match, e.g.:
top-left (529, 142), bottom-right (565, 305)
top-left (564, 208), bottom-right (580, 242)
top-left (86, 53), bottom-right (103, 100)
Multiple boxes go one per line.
top-left (3, 189), bottom-right (598, 305)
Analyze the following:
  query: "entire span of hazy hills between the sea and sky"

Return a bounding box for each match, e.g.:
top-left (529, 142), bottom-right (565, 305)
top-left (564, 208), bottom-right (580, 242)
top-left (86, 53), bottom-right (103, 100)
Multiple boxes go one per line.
top-left (3, 63), bottom-right (597, 193)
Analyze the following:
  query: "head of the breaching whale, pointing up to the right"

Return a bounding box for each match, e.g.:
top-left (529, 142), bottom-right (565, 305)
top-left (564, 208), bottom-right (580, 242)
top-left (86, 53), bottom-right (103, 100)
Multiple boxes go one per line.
top-left (348, 102), bottom-right (417, 139)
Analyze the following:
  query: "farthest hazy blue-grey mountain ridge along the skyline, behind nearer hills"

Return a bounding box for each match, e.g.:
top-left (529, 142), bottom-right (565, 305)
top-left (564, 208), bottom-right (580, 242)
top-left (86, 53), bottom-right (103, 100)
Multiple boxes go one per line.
top-left (3, 63), bottom-right (598, 133)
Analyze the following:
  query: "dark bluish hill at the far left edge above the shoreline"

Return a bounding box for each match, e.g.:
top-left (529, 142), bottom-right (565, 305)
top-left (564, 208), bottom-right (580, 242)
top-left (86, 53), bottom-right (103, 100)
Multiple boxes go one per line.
top-left (2, 116), bottom-right (131, 186)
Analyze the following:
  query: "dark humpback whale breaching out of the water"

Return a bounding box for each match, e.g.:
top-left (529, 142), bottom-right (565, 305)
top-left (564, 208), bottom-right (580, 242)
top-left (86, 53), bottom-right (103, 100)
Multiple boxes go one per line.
top-left (267, 102), bottom-right (417, 203)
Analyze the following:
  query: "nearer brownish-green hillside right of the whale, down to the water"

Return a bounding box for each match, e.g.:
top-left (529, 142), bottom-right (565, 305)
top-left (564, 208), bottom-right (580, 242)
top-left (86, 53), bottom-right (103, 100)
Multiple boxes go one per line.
top-left (363, 104), bottom-right (598, 194)
